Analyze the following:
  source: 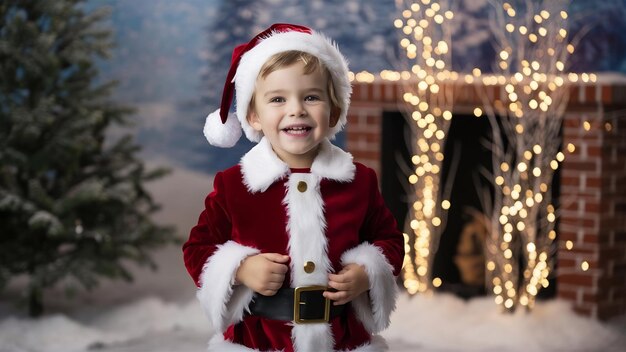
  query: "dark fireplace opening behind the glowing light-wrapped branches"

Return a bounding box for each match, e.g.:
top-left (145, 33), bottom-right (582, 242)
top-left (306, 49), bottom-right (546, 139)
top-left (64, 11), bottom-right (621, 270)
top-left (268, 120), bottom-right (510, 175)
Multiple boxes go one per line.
top-left (380, 111), bottom-right (560, 298)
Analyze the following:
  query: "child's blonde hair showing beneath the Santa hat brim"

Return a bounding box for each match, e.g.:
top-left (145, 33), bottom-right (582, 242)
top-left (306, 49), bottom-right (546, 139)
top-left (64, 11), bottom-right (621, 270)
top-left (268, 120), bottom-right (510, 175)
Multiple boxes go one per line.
top-left (250, 50), bottom-right (340, 109)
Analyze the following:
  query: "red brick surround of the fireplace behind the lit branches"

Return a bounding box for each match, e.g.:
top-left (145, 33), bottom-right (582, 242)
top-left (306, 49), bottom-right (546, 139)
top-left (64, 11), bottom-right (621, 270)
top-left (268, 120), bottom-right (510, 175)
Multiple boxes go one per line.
top-left (346, 75), bottom-right (626, 320)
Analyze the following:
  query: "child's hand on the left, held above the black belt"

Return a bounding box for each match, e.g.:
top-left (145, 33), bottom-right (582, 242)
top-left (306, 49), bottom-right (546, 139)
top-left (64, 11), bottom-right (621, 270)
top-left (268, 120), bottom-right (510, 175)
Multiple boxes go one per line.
top-left (235, 253), bottom-right (289, 296)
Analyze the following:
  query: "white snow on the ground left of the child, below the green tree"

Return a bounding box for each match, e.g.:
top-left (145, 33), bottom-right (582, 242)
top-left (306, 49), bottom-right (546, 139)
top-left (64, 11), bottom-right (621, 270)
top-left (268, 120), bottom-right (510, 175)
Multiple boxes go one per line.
top-left (0, 298), bottom-right (207, 352)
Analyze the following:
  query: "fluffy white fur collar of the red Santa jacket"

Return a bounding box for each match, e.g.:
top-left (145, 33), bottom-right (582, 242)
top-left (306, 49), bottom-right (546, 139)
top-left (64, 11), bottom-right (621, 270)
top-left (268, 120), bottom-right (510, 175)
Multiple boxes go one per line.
top-left (239, 137), bottom-right (356, 193)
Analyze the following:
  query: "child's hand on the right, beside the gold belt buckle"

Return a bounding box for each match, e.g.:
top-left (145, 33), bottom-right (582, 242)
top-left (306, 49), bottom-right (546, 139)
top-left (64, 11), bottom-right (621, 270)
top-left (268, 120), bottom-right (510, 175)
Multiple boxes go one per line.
top-left (324, 264), bottom-right (370, 305)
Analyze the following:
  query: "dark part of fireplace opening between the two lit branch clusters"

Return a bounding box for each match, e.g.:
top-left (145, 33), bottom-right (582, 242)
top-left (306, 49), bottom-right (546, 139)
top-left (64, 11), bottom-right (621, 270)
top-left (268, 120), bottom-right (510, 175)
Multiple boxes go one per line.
top-left (432, 114), bottom-right (493, 298)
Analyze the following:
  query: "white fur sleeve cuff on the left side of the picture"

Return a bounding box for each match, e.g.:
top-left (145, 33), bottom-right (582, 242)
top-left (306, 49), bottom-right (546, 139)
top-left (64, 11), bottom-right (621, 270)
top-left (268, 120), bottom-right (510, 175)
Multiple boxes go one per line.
top-left (196, 241), bottom-right (259, 333)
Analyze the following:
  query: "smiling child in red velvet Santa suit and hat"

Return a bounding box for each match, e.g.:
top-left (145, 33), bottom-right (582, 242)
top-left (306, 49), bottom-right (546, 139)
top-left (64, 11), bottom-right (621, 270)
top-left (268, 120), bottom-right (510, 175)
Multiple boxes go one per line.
top-left (183, 24), bottom-right (404, 352)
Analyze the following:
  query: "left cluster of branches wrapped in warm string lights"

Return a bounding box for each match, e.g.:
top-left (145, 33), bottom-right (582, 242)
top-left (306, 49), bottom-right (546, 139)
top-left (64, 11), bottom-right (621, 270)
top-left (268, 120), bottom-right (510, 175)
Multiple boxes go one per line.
top-left (394, 0), bottom-right (459, 294)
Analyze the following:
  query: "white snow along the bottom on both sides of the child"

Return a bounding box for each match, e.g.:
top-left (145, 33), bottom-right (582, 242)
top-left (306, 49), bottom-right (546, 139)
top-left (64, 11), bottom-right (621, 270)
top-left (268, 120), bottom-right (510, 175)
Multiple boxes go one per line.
top-left (0, 294), bottom-right (626, 352)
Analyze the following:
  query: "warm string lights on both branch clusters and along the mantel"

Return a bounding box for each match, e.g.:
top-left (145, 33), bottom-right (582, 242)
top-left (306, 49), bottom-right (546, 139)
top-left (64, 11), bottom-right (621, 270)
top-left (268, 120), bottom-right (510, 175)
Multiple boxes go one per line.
top-left (380, 0), bottom-right (584, 311)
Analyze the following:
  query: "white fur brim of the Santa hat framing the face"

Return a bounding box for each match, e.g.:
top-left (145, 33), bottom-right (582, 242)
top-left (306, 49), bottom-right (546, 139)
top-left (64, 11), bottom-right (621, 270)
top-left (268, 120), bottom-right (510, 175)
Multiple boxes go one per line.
top-left (234, 31), bottom-right (352, 142)
